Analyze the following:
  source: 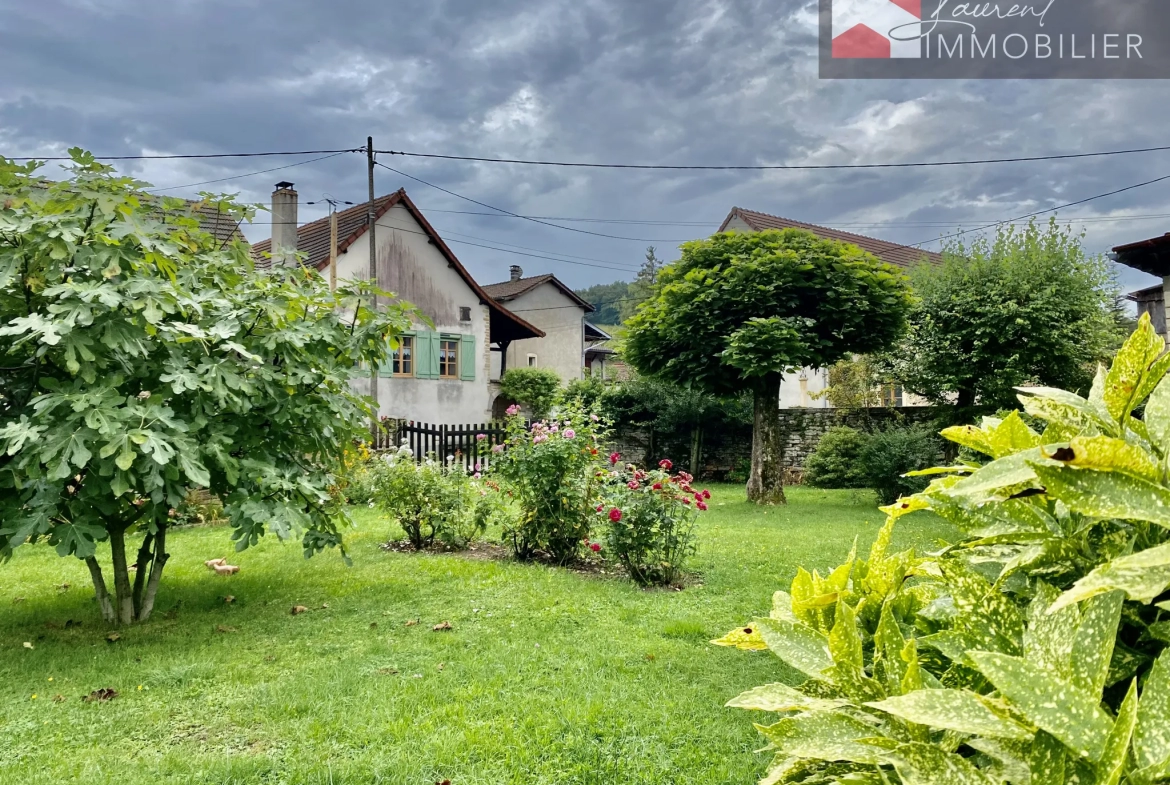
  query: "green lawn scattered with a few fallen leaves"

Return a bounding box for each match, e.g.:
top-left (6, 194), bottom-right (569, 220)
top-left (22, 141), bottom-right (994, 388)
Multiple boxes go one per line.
top-left (0, 487), bottom-right (949, 785)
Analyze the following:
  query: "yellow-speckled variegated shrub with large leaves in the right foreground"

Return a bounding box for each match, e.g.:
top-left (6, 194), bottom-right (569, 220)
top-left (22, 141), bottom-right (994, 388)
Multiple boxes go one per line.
top-left (716, 317), bottom-right (1170, 785)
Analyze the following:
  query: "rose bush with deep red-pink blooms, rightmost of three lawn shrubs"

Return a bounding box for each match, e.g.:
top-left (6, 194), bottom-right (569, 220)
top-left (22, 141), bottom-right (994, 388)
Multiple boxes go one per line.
top-left (597, 455), bottom-right (711, 585)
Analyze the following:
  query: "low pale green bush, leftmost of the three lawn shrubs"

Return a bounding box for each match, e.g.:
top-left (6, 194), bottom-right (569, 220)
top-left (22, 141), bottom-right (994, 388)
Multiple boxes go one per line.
top-left (372, 446), bottom-right (487, 549)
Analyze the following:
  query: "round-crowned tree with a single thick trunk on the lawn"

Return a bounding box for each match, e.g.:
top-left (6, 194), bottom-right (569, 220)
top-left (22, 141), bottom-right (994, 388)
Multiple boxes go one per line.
top-left (624, 229), bottom-right (910, 503)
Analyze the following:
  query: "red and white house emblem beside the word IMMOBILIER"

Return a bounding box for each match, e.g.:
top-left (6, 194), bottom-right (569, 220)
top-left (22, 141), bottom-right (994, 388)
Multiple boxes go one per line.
top-left (832, 0), bottom-right (922, 58)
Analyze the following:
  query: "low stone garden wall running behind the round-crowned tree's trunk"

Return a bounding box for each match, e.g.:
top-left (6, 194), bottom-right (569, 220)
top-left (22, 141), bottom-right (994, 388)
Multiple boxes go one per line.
top-left (612, 406), bottom-right (938, 480)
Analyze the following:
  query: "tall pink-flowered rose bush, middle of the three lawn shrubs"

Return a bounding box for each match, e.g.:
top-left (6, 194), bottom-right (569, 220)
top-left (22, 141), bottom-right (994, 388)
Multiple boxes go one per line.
top-left (491, 406), bottom-right (606, 564)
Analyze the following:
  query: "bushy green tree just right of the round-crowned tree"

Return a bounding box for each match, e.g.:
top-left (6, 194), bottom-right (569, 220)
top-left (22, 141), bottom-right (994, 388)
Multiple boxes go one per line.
top-left (890, 219), bottom-right (1124, 421)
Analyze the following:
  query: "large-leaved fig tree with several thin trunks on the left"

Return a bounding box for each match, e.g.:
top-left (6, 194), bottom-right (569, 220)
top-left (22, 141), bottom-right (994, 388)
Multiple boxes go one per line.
top-left (0, 150), bottom-right (413, 624)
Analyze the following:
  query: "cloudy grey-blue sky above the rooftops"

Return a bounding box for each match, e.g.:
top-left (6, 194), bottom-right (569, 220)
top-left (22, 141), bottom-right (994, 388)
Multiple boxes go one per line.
top-left (0, 0), bottom-right (1170, 290)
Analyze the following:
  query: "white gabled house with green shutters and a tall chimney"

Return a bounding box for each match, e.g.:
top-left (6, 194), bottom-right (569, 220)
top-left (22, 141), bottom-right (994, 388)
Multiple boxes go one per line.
top-left (253, 183), bottom-right (545, 424)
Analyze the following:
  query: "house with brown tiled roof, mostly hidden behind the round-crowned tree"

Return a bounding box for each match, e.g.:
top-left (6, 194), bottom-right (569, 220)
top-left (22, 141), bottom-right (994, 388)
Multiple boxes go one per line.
top-left (718, 207), bottom-right (942, 409)
